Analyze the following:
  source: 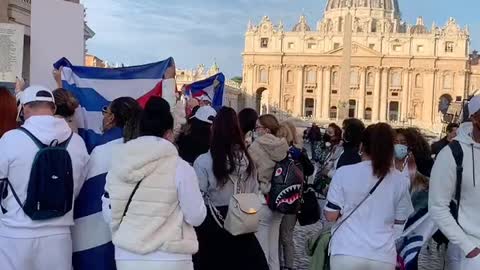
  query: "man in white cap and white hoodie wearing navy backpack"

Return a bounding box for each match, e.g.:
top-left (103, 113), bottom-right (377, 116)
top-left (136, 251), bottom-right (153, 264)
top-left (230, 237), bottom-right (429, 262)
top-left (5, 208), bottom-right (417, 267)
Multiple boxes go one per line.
top-left (0, 86), bottom-right (88, 270)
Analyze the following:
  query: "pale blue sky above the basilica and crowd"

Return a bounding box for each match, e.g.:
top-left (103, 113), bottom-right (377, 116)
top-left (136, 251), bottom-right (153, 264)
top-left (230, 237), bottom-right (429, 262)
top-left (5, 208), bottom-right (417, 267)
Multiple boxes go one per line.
top-left (82, 0), bottom-right (480, 77)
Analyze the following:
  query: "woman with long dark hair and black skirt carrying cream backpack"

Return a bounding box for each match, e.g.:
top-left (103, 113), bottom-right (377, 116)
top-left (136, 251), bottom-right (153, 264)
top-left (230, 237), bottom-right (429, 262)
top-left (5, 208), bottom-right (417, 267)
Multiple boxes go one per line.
top-left (194, 107), bottom-right (268, 270)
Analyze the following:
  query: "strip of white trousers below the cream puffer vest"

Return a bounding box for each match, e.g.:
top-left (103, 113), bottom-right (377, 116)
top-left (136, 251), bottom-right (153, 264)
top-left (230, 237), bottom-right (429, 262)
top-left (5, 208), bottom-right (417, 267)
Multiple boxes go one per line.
top-left (116, 261), bottom-right (193, 270)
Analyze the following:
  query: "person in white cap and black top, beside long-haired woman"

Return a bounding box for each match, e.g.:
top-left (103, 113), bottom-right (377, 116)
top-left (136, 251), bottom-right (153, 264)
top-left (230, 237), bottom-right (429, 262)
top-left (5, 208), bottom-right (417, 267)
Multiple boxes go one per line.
top-left (176, 106), bottom-right (217, 164)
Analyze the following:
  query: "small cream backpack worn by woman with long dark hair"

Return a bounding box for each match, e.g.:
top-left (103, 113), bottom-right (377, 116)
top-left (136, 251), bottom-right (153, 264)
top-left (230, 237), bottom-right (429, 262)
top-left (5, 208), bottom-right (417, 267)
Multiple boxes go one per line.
top-left (209, 176), bottom-right (262, 236)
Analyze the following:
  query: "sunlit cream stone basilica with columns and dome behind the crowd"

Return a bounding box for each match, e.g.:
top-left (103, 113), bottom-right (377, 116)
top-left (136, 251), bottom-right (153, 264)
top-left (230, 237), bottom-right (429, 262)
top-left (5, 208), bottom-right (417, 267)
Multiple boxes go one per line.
top-left (243, 0), bottom-right (474, 128)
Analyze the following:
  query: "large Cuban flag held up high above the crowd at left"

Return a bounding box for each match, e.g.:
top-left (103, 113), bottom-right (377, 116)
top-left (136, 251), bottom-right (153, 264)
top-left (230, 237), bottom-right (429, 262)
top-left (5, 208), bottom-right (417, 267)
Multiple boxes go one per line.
top-left (54, 58), bottom-right (176, 152)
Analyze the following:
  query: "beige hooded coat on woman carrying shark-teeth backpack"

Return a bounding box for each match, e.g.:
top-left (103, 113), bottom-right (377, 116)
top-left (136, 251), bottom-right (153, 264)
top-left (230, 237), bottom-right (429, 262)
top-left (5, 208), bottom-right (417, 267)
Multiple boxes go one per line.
top-left (248, 134), bottom-right (289, 194)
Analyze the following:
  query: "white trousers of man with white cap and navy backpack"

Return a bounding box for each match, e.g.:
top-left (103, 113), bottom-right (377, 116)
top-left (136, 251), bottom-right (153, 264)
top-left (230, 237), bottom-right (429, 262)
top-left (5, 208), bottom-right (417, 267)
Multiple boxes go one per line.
top-left (0, 234), bottom-right (72, 270)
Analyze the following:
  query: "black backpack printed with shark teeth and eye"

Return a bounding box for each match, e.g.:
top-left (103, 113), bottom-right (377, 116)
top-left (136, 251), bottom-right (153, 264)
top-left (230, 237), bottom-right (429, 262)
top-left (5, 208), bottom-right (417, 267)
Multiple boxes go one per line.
top-left (268, 155), bottom-right (305, 215)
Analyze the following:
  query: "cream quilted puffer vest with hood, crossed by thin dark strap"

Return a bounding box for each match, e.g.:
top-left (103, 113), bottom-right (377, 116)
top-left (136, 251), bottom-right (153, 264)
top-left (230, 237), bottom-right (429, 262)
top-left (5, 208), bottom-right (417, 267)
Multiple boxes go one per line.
top-left (107, 137), bottom-right (198, 255)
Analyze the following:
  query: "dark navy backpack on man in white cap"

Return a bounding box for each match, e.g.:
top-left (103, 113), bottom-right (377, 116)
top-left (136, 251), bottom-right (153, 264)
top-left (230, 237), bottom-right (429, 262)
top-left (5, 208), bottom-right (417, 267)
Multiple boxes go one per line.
top-left (0, 128), bottom-right (73, 220)
